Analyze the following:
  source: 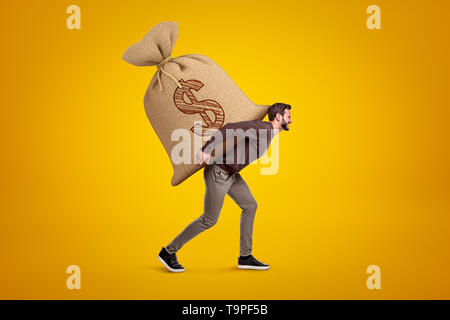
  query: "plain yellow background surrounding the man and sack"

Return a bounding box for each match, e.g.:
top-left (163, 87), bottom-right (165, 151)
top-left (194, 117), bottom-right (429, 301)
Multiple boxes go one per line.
top-left (0, 0), bottom-right (450, 299)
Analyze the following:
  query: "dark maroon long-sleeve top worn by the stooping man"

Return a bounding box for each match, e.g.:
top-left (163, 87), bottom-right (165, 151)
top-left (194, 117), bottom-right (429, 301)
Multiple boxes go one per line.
top-left (202, 120), bottom-right (275, 174)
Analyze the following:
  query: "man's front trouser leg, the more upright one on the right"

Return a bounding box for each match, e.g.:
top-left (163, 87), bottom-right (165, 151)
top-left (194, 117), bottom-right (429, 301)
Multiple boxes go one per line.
top-left (228, 173), bottom-right (257, 256)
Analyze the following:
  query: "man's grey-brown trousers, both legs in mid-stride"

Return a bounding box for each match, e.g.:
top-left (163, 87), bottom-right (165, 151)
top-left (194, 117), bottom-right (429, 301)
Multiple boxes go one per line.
top-left (166, 164), bottom-right (257, 256)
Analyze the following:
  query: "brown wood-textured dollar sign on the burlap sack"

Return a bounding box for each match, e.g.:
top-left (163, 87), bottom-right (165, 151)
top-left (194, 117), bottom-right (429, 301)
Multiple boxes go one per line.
top-left (173, 79), bottom-right (225, 136)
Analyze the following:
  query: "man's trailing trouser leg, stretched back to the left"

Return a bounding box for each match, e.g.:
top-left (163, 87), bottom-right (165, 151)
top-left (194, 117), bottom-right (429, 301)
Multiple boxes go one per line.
top-left (166, 165), bottom-right (233, 254)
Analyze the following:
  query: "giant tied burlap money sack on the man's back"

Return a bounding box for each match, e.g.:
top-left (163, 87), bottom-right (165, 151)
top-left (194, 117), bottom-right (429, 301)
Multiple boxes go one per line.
top-left (122, 21), bottom-right (269, 186)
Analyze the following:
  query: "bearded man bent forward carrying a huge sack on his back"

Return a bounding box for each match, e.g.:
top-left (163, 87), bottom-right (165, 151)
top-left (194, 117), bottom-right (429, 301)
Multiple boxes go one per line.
top-left (158, 103), bottom-right (292, 272)
